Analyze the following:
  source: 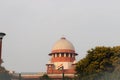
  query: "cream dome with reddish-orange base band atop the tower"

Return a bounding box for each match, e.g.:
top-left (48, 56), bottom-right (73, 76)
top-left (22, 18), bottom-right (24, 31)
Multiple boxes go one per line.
top-left (52, 37), bottom-right (75, 53)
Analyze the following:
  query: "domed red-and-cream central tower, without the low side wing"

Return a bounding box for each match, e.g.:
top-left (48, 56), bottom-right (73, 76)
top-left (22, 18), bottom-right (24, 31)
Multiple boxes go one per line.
top-left (46, 37), bottom-right (78, 74)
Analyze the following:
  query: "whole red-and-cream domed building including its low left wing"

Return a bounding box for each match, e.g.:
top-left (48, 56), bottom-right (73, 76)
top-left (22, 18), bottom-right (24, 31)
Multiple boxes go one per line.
top-left (12, 37), bottom-right (78, 80)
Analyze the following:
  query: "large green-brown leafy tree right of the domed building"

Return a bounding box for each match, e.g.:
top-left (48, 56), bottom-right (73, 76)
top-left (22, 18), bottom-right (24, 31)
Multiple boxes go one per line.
top-left (75, 46), bottom-right (120, 80)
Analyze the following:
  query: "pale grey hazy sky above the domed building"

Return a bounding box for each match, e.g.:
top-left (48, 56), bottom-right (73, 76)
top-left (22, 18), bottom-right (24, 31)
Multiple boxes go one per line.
top-left (0, 0), bottom-right (120, 72)
